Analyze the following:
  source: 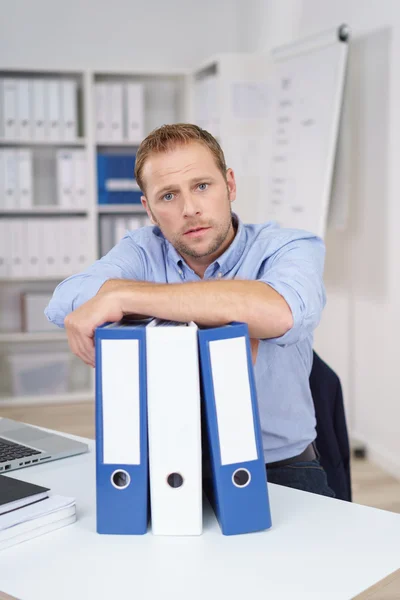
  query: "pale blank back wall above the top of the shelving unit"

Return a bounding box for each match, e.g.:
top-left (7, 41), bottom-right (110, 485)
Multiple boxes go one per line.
top-left (0, 0), bottom-right (246, 70)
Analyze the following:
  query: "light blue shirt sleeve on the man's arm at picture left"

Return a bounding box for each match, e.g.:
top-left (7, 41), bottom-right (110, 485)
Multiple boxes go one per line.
top-left (44, 235), bottom-right (145, 327)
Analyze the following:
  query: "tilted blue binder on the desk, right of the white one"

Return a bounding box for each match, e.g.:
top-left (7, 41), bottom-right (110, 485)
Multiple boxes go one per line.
top-left (198, 323), bottom-right (271, 535)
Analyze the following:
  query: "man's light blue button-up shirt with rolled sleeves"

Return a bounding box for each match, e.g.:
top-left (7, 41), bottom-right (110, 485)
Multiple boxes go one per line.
top-left (45, 216), bottom-right (326, 462)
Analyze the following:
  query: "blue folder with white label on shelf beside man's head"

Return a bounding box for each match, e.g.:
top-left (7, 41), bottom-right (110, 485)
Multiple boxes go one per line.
top-left (97, 152), bottom-right (142, 204)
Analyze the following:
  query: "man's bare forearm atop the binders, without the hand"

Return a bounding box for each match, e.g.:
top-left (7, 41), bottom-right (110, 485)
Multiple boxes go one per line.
top-left (100, 279), bottom-right (293, 339)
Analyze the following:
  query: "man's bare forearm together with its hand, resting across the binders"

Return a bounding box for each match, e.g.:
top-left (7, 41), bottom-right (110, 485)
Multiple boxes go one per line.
top-left (64, 279), bottom-right (293, 366)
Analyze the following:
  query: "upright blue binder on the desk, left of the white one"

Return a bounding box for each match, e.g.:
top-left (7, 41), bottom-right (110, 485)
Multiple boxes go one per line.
top-left (95, 321), bottom-right (149, 535)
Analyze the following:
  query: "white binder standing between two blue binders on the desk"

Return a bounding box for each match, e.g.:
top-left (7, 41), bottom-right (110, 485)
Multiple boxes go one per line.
top-left (146, 320), bottom-right (202, 535)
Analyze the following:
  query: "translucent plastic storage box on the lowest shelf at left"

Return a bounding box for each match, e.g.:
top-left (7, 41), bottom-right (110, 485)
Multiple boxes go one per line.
top-left (8, 352), bottom-right (70, 396)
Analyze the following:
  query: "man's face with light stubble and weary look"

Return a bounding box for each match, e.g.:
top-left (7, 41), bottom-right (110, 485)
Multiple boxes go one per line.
top-left (142, 142), bottom-right (236, 265)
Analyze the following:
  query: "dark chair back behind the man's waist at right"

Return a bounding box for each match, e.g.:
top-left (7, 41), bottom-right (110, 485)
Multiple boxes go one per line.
top-left (310, 351), bottom-right (352, 502)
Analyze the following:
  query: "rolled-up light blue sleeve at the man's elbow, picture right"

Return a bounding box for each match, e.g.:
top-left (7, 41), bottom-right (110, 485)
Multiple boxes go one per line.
top-left (258, 232), bottom-right (326, 346)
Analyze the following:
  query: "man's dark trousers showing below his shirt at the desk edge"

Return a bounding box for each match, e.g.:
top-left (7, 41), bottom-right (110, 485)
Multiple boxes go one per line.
top-left (267, 459), bottom-right (335, 498)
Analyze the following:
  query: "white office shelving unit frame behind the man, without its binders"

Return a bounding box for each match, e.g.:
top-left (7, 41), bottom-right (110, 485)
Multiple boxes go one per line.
top-left (0, 68), bottom-right (191, 408)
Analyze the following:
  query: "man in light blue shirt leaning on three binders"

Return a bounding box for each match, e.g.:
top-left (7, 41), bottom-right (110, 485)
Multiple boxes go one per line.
top-left (46, 124), bottom-right (334, 496)
